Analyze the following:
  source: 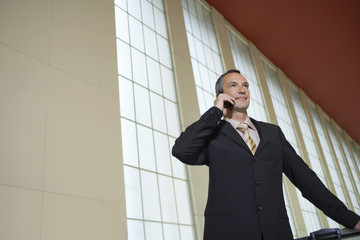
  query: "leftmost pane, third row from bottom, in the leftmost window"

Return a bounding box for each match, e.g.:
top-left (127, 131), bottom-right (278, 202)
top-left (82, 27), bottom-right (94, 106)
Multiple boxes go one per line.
top-left (121, 118), bottom-right (139, 167)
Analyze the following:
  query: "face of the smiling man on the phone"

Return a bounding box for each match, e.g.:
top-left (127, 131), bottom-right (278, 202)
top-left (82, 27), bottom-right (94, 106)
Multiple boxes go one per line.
top-left (223, 73), bottom-right (250, 111)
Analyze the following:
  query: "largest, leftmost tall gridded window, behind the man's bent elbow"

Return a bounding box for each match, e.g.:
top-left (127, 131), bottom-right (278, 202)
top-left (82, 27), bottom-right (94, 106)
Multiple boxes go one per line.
top-left (115, 0), bottom-right (194, 240)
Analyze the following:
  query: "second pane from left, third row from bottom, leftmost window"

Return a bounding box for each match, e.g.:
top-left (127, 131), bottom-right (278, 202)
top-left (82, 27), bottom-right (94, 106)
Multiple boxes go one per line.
top-left (137, 125), bottom-right (156, 171)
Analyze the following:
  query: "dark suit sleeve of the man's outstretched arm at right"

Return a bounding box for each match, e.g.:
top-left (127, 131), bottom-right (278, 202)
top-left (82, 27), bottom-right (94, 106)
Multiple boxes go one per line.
top-left (279, 126), bottom-right (360, 229)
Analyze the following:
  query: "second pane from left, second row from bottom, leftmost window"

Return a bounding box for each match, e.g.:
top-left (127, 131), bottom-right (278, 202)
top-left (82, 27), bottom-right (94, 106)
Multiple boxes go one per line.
top-left (141, 170), bottom-right (161, 221)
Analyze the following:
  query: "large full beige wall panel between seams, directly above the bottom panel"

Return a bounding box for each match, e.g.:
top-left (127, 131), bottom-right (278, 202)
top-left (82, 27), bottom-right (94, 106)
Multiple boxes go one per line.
top-left (44, 69), bottom-right (102, 199)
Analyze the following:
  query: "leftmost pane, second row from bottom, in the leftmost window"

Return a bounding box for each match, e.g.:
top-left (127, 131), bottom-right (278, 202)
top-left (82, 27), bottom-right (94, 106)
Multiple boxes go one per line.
top-left (124, 166), bottom-right (143, 219)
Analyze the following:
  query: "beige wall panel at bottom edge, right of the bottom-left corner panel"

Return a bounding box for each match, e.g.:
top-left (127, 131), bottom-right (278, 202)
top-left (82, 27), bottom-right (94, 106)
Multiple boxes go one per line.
top-left (43, 193), bottom-right (104, 240)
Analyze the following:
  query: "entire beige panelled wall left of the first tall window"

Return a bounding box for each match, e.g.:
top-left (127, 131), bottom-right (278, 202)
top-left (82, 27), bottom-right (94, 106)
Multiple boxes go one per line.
top-left (0, 0), bottom-right (127, 240)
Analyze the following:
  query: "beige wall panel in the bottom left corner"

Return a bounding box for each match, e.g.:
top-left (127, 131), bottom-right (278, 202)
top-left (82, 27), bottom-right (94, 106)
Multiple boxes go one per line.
top-left (0, 185), bottom-right (42, 240)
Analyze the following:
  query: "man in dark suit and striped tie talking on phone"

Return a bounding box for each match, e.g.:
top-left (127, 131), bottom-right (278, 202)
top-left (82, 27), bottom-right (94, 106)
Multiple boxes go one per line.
top-left (172, 70), bottom-right (360, 240)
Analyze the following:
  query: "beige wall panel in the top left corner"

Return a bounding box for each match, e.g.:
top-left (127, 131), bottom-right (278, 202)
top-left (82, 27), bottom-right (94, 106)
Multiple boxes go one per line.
top-left (0, 0), bottom-right (51, 62)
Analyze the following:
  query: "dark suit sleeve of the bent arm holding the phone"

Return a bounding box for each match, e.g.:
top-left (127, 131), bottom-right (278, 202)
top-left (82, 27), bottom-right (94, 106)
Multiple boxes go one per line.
top-left (172, 107), bottom-right (222, 165)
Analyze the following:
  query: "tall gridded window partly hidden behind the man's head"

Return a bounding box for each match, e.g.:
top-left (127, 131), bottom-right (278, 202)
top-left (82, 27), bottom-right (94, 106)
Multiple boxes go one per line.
top-left (182, 0), bottom-right (224, 114)
